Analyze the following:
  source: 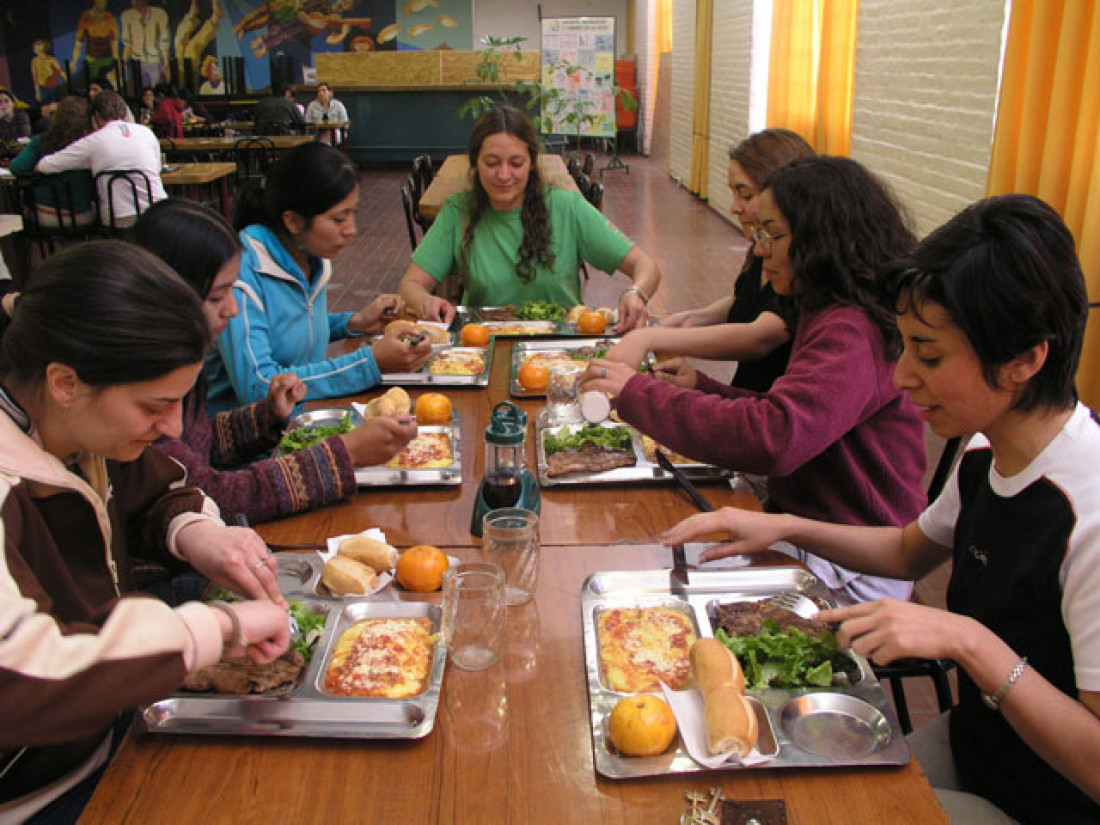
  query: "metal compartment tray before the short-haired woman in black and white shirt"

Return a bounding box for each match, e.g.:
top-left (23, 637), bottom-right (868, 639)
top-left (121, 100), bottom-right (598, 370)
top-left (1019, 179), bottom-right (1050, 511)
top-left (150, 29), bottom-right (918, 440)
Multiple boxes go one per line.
top-left (581, 567), bottom-right (910, 779)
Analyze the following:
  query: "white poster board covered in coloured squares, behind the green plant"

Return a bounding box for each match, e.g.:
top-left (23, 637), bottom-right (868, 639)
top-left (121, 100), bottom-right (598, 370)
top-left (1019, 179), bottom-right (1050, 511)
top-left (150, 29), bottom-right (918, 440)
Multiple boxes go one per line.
top-left (541, 18), bottom-right (615, 138)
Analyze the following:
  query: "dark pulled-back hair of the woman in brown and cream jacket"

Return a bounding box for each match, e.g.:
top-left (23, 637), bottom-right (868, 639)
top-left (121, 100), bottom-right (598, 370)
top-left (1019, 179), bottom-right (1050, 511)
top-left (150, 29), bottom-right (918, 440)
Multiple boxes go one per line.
top-left (0, 241), bottom-right (210, 387)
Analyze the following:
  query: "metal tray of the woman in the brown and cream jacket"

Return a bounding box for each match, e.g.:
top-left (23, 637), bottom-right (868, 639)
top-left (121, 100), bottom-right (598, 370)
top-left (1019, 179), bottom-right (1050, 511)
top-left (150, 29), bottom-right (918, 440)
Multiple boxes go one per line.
top-left (138, 601), bottom-right (447, 739)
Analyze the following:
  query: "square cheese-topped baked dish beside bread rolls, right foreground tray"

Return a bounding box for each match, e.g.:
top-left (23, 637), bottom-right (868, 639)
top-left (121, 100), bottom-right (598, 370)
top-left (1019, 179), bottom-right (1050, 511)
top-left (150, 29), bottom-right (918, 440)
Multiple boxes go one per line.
top-left (596, 607), bottom-right (695, 693)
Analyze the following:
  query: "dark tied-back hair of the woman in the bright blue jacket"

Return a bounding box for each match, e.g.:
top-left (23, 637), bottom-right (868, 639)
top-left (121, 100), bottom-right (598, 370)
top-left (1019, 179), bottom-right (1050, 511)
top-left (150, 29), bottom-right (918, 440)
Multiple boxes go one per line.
top-left (234, 141), bottom-right (359, 235)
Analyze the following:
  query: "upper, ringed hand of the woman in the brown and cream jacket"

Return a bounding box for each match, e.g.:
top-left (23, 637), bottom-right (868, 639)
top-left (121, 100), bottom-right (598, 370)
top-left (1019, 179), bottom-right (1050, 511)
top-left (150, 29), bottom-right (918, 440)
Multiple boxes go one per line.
top-left (176, 519), bottom-right (286, 609)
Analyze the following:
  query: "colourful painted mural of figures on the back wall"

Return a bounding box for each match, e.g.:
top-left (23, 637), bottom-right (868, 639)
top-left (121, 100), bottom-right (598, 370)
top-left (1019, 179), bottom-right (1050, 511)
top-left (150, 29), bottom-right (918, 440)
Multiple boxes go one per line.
top-left (0, 0), bottom-right (473, 106)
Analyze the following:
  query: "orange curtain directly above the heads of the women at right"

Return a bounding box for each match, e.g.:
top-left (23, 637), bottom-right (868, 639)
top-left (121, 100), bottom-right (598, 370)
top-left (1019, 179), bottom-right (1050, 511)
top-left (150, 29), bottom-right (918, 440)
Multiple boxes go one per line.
top-left (767, 0), bottom-right (859, 155)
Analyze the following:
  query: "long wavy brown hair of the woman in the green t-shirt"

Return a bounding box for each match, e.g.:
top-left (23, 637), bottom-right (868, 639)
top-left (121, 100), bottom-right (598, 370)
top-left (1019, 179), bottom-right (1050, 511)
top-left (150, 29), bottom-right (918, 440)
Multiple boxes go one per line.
top-left (459, 106), bottom-right (554, 284)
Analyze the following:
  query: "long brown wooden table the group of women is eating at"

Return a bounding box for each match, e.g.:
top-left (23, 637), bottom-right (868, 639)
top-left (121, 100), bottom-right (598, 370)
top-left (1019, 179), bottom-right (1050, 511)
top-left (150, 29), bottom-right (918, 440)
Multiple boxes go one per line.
top-left (81, 343), bottom-right (946, 825)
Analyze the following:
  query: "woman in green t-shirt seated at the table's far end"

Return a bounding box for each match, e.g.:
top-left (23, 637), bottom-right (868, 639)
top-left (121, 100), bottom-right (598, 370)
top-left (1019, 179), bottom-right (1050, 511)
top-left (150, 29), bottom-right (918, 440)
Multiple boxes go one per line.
top-left (398, 106), bottom-right (661, 332)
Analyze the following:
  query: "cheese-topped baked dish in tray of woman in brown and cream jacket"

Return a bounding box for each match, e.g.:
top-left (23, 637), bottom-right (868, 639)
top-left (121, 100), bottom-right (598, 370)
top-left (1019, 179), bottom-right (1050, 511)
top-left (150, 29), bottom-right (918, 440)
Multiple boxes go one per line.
top-left (325, 616), bottom-right (435, 699)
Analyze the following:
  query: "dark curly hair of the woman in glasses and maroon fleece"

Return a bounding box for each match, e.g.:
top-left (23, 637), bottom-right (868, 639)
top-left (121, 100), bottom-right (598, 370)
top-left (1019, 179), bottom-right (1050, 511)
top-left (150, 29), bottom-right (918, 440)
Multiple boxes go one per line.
top-left (765, 155), bottom-right (916, 349)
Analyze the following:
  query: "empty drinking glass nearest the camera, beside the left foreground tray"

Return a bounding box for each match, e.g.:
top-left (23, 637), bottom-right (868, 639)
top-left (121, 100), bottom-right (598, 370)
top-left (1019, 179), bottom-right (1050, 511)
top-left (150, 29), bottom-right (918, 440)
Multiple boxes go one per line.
top-left (443, 561), bottom-right (507, 670)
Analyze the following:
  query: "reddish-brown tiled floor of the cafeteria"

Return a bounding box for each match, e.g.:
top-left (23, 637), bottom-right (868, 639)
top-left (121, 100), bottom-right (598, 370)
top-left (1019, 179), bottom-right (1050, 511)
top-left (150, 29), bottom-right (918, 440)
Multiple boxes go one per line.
top-left (330, 151), bottom-right (947, 727)
